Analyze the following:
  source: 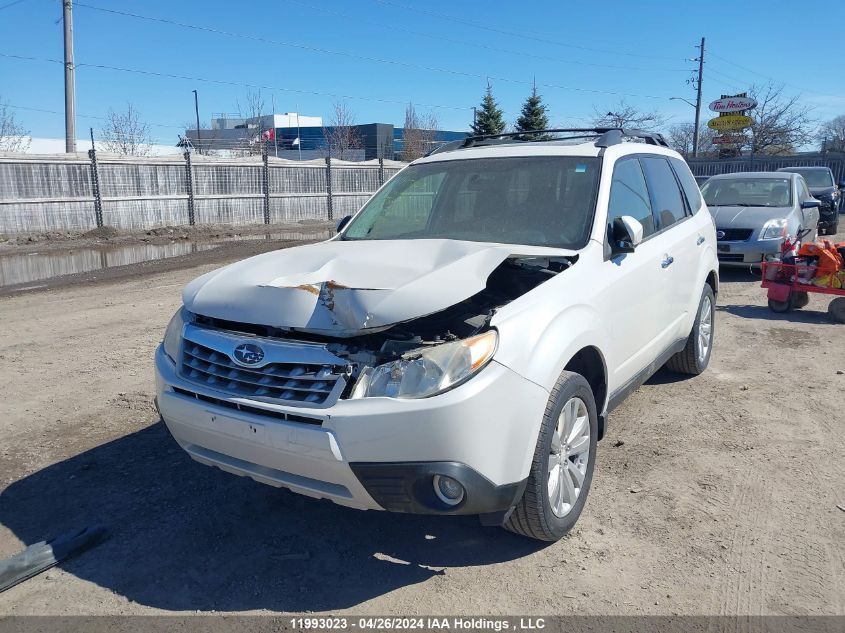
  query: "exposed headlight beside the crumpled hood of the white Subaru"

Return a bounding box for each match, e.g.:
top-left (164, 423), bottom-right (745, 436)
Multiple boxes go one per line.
top-left (349, 330), bottom-right (499, 398)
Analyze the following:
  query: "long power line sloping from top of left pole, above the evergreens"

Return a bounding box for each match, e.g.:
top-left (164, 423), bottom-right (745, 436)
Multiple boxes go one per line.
top-left (66, 2), bottom-right (668, 100)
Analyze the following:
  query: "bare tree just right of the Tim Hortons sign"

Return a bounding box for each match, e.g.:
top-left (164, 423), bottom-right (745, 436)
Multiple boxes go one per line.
top-left (743, 82), bottom-right (814, 154)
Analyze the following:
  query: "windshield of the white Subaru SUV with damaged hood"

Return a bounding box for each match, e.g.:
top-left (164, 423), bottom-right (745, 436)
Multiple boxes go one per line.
top-left (341, 156), bottom-right (601, 249)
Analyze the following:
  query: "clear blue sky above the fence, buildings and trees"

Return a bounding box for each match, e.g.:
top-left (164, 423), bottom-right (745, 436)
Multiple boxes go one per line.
top-left (0, 0), bottom-right (845, 144)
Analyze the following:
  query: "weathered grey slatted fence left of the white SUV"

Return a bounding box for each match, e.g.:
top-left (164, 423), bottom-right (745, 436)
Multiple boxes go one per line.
top-left (0, 151), bottom-right (404, 234)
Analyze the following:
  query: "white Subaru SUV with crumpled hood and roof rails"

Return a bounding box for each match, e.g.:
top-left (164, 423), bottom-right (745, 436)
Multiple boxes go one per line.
top-left (156, 129), bottom-right (718, 540)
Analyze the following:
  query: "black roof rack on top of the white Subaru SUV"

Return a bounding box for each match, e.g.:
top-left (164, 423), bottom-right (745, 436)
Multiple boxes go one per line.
top-left (428, 127), bottom-right (669, 156)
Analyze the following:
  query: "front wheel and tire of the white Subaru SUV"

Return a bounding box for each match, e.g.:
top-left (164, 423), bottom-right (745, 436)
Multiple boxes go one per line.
top-left (504, 371), bottom-right (598, 541)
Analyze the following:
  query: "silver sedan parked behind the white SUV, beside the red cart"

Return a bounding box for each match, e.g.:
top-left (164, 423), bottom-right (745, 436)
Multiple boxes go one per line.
top-left (701, 172), bottom-right (820, 266)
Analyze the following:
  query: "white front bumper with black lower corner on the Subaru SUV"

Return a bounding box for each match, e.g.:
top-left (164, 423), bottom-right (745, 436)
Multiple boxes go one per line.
top-left (156, 347), bottom-right (549, 514)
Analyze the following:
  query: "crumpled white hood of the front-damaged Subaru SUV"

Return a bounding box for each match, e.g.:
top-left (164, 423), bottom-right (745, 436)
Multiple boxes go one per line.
top-left (182, 240), bottom-right (574, 337)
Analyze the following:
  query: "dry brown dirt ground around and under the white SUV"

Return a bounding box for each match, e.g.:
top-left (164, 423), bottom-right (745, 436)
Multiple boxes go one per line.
top-left (0, 228), bottom-right (845, 615)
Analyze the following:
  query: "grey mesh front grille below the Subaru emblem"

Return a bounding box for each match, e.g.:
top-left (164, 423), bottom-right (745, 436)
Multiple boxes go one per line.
top-left (182, 338), bottom-right (346, 405)
